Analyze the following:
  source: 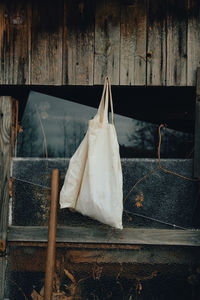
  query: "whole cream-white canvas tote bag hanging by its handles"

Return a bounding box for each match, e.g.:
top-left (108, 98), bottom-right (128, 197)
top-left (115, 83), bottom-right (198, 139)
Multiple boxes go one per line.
top-left (60, 77), bottom-right (123, 229)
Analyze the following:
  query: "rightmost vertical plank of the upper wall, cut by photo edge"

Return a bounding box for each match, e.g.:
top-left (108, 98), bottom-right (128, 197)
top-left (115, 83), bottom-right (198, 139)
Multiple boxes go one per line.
top-left (187, 0), bottom-right (200, 86)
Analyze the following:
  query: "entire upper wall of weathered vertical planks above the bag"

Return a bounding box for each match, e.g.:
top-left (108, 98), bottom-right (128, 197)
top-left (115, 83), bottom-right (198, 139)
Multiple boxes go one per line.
top-left (0, 0), bottom-right (200, 86)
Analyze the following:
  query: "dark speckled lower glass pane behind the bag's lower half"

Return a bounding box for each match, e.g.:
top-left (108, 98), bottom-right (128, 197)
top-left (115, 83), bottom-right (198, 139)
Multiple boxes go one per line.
top-left (12, 158), bottom-right (199, 229)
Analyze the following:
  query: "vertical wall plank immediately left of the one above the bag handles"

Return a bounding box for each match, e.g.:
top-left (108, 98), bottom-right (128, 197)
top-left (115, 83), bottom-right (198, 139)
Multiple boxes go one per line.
top-left (63, 0), bottom-right (95, 85)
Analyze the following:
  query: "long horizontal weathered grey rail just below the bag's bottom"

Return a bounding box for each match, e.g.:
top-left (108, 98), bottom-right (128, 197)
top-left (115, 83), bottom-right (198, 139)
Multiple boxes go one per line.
top-left (8, 226), bottom-right (200, 247)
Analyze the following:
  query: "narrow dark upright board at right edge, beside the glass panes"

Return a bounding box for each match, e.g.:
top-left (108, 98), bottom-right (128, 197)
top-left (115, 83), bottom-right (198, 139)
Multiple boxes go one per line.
top-left (194, 68), bottom-right (200, 179)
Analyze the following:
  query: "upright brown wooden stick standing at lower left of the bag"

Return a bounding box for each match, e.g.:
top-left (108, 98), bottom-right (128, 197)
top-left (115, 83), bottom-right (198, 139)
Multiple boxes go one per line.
top-left (44, 169), bottom-right (59, 300)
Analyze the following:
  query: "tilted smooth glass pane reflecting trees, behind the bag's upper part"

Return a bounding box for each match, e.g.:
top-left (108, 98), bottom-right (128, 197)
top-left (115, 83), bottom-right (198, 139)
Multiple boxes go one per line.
top-left (17, 92), bottom-right (193, 158)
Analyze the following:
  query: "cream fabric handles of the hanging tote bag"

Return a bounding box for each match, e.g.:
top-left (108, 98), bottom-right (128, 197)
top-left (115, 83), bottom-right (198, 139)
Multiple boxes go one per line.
top-left (98, 76), bottom-right (114, 124)
